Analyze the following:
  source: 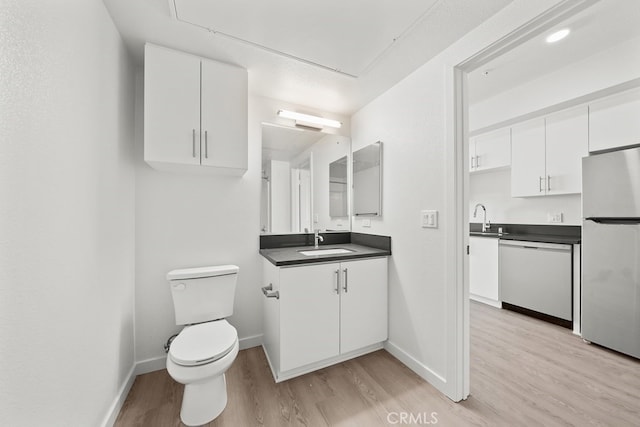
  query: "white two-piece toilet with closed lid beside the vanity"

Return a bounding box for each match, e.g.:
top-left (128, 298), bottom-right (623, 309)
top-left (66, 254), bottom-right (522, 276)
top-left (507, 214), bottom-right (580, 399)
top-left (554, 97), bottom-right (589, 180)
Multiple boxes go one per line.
top-left (167, 265), bottom-right (238, 426)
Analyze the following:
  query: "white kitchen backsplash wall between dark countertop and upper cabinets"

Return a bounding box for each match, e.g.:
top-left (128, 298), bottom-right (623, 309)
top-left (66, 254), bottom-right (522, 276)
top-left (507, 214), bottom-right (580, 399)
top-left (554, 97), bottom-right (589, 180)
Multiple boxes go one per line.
top-left (469, 169), bottom-right (582, 225)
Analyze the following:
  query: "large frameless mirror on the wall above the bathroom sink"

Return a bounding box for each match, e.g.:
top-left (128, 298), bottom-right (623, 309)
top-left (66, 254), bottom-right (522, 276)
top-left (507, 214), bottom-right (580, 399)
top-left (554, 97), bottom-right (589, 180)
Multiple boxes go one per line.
top-left (260, 123), bottom-right (351, 234)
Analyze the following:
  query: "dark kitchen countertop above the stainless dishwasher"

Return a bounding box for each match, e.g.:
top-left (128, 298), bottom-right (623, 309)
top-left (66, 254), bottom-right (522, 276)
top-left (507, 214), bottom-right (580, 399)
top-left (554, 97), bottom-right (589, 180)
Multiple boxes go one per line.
top-left (469, 223), bottom-right (582, 245)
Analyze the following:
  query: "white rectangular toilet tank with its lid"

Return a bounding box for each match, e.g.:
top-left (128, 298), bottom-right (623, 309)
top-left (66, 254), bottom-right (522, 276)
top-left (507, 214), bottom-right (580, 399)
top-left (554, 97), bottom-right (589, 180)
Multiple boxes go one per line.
top-left (167, 265), bottom-right (239, 325)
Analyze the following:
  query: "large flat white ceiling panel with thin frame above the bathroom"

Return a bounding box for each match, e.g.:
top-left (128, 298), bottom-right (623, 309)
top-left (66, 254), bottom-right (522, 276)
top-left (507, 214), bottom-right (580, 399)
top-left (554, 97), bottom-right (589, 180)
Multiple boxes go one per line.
top-left (173, 0), bottom-right (438, 77)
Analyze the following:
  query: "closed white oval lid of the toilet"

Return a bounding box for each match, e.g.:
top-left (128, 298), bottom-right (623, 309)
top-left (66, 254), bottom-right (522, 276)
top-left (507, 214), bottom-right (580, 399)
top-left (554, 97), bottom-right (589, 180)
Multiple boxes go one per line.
top-left (169, 319), bottom-right (238, 366)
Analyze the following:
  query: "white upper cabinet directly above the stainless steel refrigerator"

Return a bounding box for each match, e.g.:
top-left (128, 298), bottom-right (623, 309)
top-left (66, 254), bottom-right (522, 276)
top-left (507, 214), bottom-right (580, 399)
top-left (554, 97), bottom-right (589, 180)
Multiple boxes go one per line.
top-left (589, 88), bottom-right (640, 152)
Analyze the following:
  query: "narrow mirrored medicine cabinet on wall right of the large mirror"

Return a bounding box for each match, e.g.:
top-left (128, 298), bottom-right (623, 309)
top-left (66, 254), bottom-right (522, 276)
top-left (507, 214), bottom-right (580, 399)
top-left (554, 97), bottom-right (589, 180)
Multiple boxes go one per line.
top-left (353, 141), bottom-right (382, 216)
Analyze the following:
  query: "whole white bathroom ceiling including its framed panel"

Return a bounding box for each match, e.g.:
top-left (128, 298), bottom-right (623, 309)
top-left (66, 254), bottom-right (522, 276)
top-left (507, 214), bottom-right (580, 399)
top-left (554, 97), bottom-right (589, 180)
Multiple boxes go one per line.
top-left (103, 0), bottom-right (512, 115)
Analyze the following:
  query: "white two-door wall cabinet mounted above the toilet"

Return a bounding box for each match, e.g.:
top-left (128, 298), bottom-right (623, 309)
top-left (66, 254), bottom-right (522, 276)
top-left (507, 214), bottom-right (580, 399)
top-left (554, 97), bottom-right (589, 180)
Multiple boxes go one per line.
top-left (144, 44), bottom-right (248, 174)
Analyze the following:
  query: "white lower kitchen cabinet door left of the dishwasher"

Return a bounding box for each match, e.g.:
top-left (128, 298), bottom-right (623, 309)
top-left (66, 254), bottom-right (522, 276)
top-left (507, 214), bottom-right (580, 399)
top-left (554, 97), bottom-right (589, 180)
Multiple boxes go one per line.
top-left (469, 237), bottom-right (498, 301)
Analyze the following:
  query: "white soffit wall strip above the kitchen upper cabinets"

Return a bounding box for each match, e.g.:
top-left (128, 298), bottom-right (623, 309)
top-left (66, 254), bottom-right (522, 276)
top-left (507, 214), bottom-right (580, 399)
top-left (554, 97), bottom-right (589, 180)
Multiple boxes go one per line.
top-left (469, 38), bottom-right (640, 130)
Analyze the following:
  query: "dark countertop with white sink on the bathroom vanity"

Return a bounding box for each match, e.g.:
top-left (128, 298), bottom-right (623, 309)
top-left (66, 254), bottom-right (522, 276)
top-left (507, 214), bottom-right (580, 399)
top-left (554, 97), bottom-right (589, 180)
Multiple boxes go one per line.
top-left (260, 243), bottom-right (391, 267)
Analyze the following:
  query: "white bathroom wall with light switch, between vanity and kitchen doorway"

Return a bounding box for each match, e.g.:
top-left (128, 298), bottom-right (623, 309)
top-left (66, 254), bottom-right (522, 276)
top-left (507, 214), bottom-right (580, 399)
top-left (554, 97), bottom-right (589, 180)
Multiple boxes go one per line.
top-left (351, 0), bottom-right (557, 398)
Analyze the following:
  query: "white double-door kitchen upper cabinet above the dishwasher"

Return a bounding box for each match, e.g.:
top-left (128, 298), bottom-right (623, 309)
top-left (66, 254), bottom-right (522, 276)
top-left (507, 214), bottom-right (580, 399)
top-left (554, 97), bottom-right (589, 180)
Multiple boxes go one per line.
top-left (511, 106), bottom-right (589, 197)
